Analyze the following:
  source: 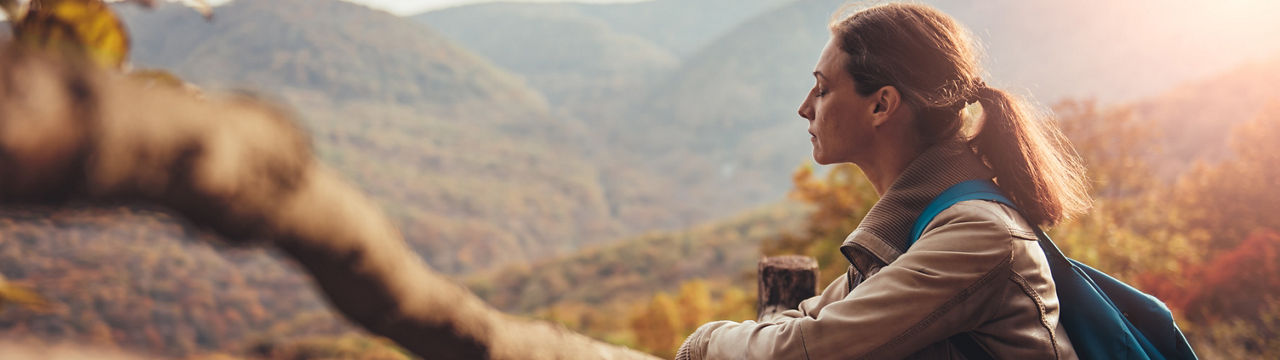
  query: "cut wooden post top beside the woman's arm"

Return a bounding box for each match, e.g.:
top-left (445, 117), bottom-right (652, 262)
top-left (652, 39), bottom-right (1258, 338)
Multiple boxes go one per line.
top-left (755, 255), bottom-right (818, 320)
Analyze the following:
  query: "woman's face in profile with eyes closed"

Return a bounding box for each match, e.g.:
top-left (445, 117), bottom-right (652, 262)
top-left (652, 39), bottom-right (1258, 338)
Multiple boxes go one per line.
top-left (800, 38), bottom-right (876, 165)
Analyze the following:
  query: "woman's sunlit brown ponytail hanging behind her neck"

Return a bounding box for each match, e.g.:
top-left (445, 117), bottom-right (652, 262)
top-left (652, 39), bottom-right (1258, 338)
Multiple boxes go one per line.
top-left (973, 85), bottom-right (1092, 225)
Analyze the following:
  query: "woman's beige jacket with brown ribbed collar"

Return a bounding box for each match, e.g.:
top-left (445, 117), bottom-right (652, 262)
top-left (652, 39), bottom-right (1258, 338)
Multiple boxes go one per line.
top-left (677, 141), bottom-right (1076, 359)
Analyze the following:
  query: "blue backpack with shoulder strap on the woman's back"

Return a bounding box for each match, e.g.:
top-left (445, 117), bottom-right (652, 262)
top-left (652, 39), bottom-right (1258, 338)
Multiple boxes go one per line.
top-left (906, 179), bottom-right (1197, 360)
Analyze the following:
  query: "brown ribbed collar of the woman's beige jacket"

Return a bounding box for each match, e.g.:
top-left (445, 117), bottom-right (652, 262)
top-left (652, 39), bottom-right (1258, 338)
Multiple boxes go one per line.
top-left (840, 138), bottom-right (993, 275)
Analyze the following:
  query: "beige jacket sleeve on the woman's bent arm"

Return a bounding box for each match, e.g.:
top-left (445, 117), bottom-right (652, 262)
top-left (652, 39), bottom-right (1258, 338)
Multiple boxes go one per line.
top-left (682, 202), bottom-right (1012, 359)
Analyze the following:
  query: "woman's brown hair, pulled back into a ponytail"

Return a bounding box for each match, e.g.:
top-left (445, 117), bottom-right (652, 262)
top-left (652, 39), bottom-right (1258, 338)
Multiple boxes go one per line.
top-left (829, 4), bottom-right (1091, 225)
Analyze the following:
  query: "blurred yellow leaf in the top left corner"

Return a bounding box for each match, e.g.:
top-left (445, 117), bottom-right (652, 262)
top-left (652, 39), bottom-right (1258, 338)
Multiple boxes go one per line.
top-left (14, 0), bottom-right (129, 68)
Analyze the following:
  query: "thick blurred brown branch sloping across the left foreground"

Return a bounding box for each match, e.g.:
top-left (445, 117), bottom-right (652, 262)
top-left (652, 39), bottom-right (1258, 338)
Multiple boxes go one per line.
top-left (0, 45), bottom-right (650, 359)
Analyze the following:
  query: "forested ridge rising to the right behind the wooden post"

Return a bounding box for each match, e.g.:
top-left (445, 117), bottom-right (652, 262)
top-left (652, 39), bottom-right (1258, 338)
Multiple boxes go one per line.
top-left (467, 202), bottom-right (809, 313)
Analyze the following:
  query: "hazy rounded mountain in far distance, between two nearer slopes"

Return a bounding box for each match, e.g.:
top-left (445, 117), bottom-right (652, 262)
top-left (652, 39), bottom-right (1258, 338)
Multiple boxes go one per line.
top-left (415, 4), bottom-right (677, 108)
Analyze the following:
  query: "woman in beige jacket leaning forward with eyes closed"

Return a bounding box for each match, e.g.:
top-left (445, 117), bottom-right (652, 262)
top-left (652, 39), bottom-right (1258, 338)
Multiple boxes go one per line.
top-left (677, 4), bottom-right (1089, 359)
